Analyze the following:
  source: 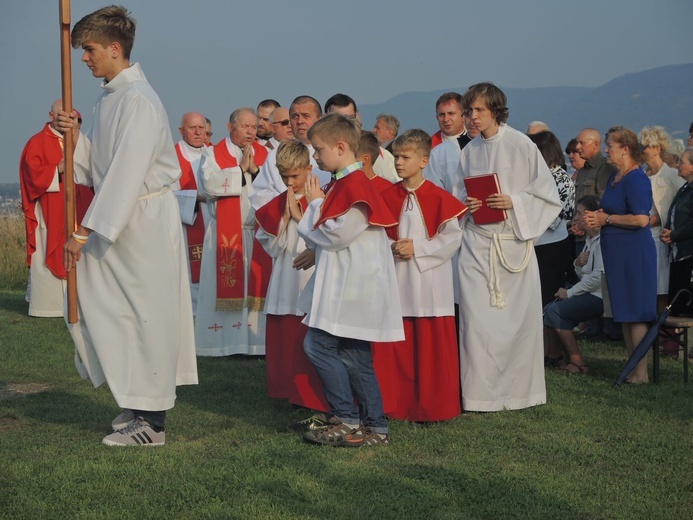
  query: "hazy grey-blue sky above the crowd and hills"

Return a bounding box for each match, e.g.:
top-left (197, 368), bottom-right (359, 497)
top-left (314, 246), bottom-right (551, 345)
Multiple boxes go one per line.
top-left (0, 0), bottom-right (693, 183)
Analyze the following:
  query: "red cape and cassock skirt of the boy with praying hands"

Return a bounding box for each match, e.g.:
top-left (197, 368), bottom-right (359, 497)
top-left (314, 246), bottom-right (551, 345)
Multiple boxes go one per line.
top-left (255, 191), bottom-right (329, 412)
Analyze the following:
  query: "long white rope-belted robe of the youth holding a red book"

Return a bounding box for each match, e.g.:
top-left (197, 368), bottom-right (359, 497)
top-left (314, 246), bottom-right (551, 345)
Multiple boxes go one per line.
top-left (458, 124), bottom-right (561, 411)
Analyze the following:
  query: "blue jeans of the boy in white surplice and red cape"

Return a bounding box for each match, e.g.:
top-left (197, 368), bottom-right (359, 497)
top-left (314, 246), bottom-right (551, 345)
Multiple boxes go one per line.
top-left (303, 328), bottom-right (387, 434)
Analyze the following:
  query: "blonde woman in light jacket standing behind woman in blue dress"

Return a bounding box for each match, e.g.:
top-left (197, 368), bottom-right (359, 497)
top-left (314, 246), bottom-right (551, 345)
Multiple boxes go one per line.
top-left (638, 126), bottom-right (684, 312)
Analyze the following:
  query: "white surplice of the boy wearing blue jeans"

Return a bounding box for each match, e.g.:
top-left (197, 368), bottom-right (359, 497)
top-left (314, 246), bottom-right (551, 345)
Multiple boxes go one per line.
top-left (298, 199), bottom-right (404, 342)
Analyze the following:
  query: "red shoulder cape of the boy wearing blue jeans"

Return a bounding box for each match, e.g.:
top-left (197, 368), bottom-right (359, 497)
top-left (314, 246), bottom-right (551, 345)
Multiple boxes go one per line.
top-left (313, 170), bottom-right (397, 229)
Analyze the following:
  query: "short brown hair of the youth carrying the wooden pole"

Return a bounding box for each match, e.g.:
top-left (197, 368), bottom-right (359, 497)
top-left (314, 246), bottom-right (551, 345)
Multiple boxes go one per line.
top-left (71, 5), bottom-right (137, 60)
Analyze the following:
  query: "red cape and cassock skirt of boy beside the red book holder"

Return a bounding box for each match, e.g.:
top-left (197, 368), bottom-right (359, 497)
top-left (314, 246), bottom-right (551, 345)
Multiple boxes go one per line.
top-left (373, 181), bottom-right (466, 422)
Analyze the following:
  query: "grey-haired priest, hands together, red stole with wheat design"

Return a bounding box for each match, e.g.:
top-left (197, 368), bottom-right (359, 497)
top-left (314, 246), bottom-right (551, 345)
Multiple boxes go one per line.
top-left (195, 108), bottom-right (268, 356)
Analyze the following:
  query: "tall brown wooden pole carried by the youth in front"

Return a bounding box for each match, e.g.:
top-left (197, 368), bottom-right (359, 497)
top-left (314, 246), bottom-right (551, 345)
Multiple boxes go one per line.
top-left (60, 0), bottom-right (78, 323)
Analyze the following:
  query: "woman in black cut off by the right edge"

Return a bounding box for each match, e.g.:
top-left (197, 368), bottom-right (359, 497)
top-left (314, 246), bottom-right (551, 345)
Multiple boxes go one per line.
top-left (660, 147), bottom-right (693, 314)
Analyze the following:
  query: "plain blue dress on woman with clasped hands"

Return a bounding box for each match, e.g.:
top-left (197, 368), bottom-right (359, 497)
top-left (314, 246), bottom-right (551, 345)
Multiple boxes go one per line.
top-left (601, 168), bottom-right (657, 322)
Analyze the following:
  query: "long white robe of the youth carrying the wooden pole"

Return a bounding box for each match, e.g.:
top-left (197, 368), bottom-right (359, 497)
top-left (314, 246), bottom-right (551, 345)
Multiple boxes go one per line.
top-left (68, 63), bottom-right (197, 410)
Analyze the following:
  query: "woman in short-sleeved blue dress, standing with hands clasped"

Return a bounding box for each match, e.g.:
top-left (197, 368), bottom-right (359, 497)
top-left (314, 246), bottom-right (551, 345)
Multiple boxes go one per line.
top-left (584, 126), bottom-right (657, 384)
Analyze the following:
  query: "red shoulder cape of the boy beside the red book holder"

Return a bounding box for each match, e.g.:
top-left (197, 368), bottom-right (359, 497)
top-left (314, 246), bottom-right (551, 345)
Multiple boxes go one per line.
top-left (382, 181), bottom-right (467, 240)
